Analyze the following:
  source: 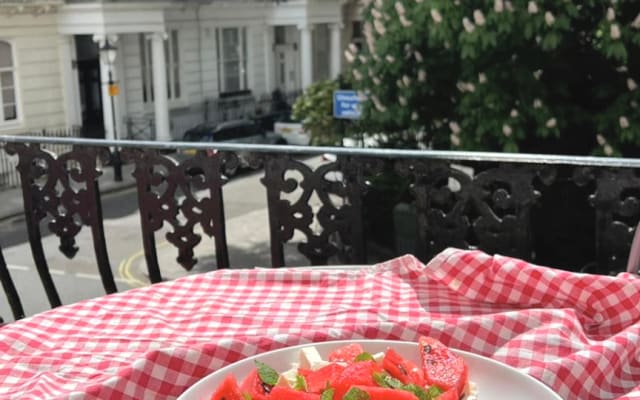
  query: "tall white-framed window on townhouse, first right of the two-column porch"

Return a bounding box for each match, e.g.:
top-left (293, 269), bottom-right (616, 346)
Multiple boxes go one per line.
top-left (216, 28), bottom-right (247, 93)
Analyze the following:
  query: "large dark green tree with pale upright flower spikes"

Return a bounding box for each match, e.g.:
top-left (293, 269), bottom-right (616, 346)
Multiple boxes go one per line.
top-left (346, 0), bottom-right (640, 155)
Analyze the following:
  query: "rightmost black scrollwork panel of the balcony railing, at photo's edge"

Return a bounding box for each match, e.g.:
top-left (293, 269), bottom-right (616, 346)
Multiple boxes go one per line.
top-left (574, 167), bottom-right (640, 273)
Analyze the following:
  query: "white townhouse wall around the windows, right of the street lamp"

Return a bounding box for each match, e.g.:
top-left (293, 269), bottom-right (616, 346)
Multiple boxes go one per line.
top-left (114, 0), bottom-right (346, 137)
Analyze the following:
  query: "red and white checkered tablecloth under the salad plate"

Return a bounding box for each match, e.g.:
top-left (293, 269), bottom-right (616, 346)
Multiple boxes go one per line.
top-left (0, 249), bottom-right (640, 400)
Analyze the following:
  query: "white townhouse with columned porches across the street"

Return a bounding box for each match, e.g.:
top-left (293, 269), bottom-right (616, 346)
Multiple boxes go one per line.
top-left (0, 0), bottom-right (361, 140)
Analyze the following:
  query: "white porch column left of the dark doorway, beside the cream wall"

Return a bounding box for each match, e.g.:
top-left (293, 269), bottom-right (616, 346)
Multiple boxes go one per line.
top-left (58, 35), bottom-right (82, 126)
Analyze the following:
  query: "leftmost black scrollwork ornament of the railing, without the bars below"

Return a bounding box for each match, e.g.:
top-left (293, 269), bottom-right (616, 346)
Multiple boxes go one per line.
top-left (6, 143), bottom-right (102, 258)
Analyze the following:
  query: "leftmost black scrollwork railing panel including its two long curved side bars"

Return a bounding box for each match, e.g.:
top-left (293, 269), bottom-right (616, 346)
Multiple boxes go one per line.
top-left (6, 143), bottom-right (117, 307)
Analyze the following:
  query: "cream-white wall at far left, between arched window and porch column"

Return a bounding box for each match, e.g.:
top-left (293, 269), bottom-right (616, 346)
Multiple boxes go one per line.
top-left (0, 15), bottom-right (66, 134)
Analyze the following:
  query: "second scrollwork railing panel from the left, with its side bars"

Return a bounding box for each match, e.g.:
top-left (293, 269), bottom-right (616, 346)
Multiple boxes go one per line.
top-left (123, 149), bottom-right (230, 281)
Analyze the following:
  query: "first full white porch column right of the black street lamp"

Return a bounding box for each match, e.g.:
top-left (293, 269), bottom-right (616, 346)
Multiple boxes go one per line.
top-left (150, 32), bottom-right (171, 141)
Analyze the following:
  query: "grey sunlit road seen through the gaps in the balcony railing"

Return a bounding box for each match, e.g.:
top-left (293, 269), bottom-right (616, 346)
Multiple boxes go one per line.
top-left (0, 158), bottom-right (319, 316)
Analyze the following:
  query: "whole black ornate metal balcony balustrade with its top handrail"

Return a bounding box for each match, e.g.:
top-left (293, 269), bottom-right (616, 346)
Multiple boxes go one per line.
top-left (0, 137), bottom-right (640, 318)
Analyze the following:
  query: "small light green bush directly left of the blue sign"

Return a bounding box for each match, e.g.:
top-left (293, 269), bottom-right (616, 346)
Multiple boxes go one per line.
top-left (292, 80), bottom-right (342, 145)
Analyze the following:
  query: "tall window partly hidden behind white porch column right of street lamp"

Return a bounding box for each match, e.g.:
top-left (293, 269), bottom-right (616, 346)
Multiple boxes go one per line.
top-left (139, 30), bottom-right (181, 103)
